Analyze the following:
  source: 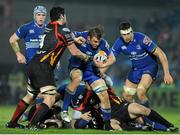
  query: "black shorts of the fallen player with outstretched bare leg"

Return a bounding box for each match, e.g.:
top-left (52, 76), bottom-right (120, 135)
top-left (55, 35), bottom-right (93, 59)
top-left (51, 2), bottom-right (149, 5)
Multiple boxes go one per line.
top-left (111, 100), bottom-right (131, 122)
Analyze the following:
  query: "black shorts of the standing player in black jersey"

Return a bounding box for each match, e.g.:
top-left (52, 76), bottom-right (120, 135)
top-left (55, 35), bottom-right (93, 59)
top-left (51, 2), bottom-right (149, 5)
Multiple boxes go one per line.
top-left (27, 59), bottom-right (56, 90)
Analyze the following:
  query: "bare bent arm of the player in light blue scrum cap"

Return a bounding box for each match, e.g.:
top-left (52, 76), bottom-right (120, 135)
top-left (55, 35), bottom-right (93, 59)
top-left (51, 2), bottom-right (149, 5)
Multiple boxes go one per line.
top-left (9, 33), bottom-right (26, 64)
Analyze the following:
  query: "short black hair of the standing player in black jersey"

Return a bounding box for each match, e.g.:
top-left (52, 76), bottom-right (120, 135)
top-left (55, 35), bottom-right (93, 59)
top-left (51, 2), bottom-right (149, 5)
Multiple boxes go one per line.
top-left (50, 7), bottom-right (64, 22)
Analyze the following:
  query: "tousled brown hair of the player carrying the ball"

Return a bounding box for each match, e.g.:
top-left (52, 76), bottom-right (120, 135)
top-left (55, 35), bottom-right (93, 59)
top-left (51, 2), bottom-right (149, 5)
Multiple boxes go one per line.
top-left (88, 25), bottom-right (104, 39)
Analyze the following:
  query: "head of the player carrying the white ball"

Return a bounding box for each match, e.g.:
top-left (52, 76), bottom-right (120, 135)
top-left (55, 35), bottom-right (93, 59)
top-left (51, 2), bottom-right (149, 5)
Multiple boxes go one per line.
top-left (87, 26), bottom-right (103, 49)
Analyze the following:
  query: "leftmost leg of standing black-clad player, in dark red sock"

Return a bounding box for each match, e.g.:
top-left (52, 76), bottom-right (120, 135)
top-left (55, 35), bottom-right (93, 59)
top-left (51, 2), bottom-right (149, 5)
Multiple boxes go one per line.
top-left (6, 85), bottom-right (37, 128)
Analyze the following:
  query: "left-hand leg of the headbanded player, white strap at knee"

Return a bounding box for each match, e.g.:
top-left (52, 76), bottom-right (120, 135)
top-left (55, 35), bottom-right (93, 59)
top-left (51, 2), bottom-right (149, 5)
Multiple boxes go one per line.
top-left (122, 79), bottom-right (137, 102)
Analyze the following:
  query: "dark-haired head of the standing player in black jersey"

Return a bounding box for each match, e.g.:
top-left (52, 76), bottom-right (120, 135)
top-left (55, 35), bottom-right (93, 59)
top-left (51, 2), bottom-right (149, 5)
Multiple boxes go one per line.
top-left (50, 7), bottom-right (66, 24)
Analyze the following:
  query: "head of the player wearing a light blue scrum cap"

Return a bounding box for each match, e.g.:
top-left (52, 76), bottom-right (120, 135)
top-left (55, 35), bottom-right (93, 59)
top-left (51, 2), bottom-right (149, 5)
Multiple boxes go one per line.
top-left (33, 6), bottom-right (47, 25)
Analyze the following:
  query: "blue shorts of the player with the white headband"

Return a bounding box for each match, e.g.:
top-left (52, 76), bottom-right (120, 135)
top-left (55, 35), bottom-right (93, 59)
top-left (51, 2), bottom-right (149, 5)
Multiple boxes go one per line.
top-left (128, 64), bottom-right (158, 84)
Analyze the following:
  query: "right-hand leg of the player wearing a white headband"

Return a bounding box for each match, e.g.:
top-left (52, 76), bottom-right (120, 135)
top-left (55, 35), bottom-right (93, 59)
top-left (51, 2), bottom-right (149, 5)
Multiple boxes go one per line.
top-left (137, 74), bottom-right (153, 107)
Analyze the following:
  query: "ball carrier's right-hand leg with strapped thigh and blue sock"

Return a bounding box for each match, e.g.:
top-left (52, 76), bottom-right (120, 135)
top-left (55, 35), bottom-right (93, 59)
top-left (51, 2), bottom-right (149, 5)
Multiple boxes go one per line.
top-left (90, 79), bottom-right (112, 130)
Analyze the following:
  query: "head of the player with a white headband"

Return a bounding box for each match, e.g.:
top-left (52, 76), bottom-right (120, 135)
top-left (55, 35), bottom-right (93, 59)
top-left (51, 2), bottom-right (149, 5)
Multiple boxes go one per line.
top-left (119, 22), bottom-right (133, 43)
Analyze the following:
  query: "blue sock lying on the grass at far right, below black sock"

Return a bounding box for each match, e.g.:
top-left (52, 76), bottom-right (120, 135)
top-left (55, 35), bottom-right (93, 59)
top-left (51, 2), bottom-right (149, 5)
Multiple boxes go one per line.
top-left (144, 117), bottom-right (167, 131)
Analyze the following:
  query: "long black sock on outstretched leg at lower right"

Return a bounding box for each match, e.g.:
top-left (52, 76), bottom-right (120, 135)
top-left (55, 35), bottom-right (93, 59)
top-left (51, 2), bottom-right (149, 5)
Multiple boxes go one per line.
top-left (147, 109), bottom-right (173, 128)
